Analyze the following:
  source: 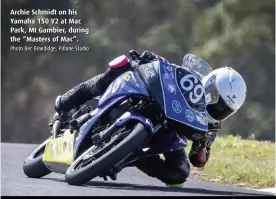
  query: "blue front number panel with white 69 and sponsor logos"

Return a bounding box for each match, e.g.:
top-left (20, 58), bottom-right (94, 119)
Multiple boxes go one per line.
top-left (160, 61), bottom-right (208, 131)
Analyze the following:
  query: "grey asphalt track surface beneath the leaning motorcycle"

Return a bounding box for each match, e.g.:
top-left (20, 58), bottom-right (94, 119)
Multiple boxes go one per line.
top-left (1, 143), bottom-right (273, 196)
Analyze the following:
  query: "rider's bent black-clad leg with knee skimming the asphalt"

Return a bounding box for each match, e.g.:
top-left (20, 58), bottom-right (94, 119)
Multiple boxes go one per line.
top-left (135, 149), bottom-right (190, 187)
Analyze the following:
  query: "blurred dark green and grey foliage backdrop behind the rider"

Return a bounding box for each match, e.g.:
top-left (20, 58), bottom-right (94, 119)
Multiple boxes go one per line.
top-left (1, 0), bottom-right (275, 143)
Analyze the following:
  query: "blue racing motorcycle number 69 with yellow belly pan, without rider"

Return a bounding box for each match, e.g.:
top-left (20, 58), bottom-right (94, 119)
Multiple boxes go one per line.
top-left (23, 51), bottom-right (216, 185)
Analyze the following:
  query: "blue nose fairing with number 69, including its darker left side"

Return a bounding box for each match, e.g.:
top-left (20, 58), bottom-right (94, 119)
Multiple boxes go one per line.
top-left (138, 61), bottom-right (208, 131)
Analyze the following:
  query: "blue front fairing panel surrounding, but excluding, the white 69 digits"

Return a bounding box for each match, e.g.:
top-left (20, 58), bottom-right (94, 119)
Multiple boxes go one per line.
top-left (159, 62), bottom-right (208, 131)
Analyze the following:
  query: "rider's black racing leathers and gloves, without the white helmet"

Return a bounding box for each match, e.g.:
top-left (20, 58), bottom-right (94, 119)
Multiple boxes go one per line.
top-left (55, 51), bottom-right (220, 186)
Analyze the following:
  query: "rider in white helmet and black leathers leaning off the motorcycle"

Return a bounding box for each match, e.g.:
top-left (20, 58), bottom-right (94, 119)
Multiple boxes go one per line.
top-left (53, 51), bottom-right (246, 187)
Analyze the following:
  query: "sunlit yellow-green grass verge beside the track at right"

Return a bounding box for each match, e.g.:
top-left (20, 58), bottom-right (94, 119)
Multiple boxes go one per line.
top-left (161, 135), bottom-right (275, 188)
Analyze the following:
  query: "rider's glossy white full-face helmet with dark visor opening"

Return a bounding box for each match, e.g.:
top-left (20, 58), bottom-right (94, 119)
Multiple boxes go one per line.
top-left (202, 67), bottom-right (246, 123)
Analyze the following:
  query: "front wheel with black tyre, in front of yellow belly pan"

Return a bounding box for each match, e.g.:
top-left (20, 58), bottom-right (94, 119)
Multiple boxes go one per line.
top-left (65, 123), bottom-right (149, 185)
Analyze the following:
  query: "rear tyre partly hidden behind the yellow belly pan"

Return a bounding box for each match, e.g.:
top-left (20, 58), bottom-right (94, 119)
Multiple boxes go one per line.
top-left (23, 140), bottom-right (51, 178)
